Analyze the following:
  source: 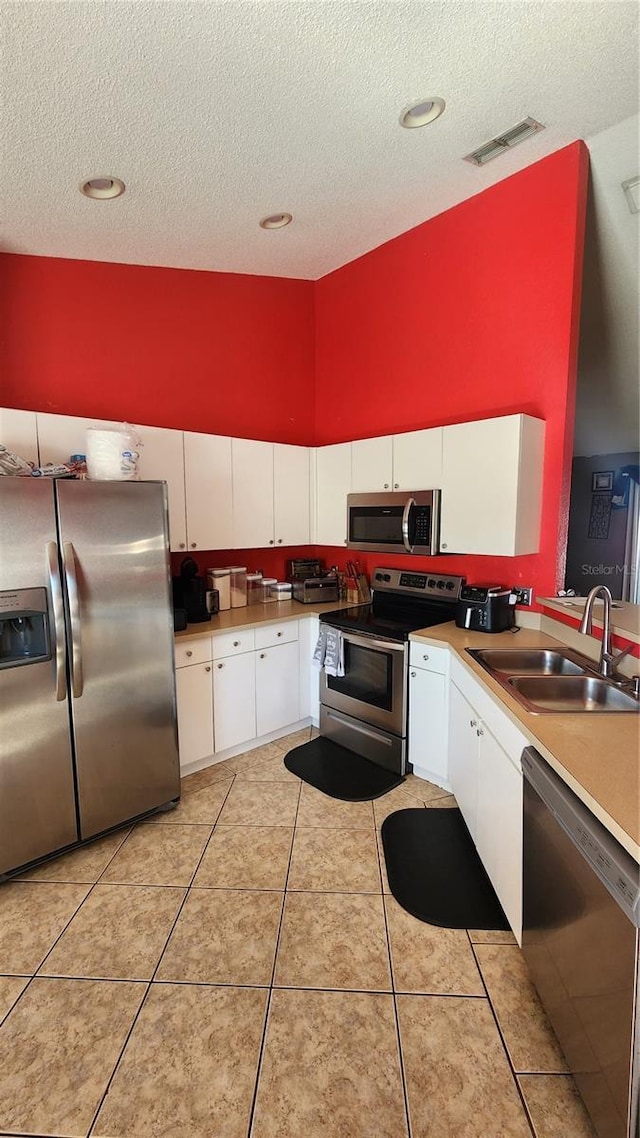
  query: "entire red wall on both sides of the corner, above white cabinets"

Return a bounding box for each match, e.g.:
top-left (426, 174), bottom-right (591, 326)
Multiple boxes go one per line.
top-left (0, 142), bottom-right (588, 593)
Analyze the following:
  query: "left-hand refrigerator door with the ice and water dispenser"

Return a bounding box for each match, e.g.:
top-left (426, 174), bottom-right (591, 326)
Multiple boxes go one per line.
top-left (0, 478), bottom-right (77, 874)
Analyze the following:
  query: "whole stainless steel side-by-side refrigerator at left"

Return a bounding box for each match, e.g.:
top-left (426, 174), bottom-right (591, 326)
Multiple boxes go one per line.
top-left (0, 477), bottom-right (180, 876)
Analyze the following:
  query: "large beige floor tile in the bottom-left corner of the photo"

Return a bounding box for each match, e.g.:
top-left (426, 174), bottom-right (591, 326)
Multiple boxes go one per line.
top-left (0, 979), bottom-right (146, 1138)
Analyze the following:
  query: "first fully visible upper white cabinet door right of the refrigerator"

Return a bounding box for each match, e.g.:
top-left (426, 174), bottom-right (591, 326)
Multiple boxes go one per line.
top-left (184, 431), bottom-right (233, 550)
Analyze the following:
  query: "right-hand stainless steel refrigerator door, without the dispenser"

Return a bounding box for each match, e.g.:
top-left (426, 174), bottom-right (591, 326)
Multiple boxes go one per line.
top-left (57, 480), bottom-right (180, 839)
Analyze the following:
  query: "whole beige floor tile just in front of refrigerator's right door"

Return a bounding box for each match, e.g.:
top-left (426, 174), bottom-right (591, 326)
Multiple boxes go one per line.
top-left (100, 824), bottom-right (212, 885)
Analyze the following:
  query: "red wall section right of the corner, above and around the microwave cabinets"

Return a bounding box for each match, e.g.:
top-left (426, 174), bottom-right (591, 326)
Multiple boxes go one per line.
top-left (315, 142), bottom-right (588, 593)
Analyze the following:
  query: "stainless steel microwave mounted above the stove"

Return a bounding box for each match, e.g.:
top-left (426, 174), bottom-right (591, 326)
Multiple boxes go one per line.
top-left (346, 490), bottom-right (441, 556)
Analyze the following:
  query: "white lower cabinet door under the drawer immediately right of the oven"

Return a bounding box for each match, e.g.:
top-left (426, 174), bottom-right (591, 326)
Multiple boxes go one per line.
top-left (409, 668), bottom-right (451, 790)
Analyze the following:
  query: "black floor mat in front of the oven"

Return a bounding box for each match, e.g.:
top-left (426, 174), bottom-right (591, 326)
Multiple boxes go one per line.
top-left (285, 736), bottom-right (404, 802)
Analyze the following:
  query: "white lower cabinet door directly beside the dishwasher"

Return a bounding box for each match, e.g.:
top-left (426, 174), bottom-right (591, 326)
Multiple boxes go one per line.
top-left (476, 725), bottom-right (523, 941)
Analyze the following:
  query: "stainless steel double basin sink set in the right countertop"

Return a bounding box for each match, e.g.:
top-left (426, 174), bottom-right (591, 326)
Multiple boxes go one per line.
top-left (467, 648), bottom-right (640, 715)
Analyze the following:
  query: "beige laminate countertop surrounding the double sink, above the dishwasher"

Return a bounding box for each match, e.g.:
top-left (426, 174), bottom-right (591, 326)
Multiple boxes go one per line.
top-left (410, 624), bottom-right (640, 861)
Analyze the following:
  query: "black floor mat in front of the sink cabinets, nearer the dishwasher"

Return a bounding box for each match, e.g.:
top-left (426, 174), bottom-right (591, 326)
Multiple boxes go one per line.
top-left (381, 807), bottom-right (510, 930)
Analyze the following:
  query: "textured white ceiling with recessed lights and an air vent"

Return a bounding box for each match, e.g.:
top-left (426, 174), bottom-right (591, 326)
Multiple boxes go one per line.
top-left (0, 0), bottom-right (638, 279)
